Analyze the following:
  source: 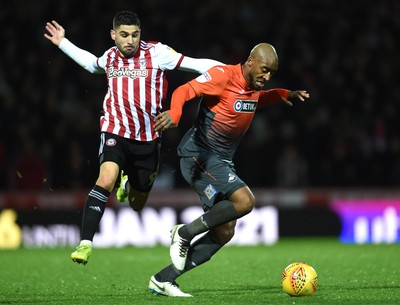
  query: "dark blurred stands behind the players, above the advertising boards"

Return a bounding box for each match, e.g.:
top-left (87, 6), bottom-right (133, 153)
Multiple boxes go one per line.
top-left (0, 0), bottom-right (400, 246)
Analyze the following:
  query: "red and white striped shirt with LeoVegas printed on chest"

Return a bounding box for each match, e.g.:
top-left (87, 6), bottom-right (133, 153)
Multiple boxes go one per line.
top-left (97, 41), bottom-right (184, 141)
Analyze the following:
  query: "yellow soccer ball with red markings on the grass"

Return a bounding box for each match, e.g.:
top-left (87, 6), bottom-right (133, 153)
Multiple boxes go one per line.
top-left (282, 262), bottom-right (318, 297)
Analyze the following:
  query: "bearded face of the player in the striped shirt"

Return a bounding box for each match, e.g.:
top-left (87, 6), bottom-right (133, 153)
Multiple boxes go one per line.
top-left (111, 25), bottom-right (140, 57)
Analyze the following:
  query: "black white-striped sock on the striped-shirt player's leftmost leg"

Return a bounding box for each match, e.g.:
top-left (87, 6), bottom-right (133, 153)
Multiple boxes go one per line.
top-left (81, 185), bottom-right (110, 240)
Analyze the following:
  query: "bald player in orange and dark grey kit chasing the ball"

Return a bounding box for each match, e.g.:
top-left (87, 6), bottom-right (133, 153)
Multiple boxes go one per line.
top-left (149, 43), bottom-right (309, 297)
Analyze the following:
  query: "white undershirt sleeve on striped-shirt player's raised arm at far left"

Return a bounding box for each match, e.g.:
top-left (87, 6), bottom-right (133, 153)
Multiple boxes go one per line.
top-left (58, 38), bottom-right (104, 74)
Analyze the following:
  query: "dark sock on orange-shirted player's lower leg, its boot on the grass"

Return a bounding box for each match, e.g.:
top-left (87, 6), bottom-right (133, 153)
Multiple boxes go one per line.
top-left (155, 234), bottom-right (223, 283)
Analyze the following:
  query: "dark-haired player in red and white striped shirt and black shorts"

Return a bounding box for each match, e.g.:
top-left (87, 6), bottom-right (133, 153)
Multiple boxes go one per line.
top-left (44, 11), bottom-right (221, 264)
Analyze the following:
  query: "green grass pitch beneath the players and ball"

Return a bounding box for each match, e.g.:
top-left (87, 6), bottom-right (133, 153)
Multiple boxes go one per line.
top-left (0, 238), bottom-right (400, 305)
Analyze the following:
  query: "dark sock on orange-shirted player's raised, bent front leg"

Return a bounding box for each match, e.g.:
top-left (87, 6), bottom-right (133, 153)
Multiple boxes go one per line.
top-left (178, 200), bottom-right (241, 240)
